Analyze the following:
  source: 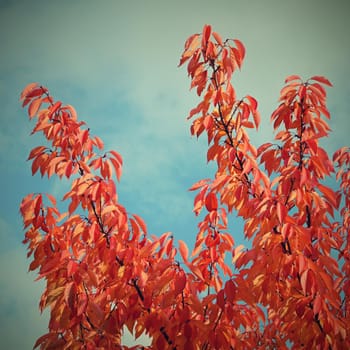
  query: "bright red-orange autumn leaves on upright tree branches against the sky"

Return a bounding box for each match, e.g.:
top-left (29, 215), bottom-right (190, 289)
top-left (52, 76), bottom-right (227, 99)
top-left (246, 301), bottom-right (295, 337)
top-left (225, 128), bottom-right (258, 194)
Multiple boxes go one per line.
top-left (20, 25), bottom-right (350, 350)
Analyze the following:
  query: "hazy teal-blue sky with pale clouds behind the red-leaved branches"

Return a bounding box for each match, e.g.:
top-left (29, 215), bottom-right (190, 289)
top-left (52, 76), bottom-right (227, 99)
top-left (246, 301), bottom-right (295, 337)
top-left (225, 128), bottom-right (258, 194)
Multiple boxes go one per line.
top-left (0, 0), bottom-right (350, 350)
